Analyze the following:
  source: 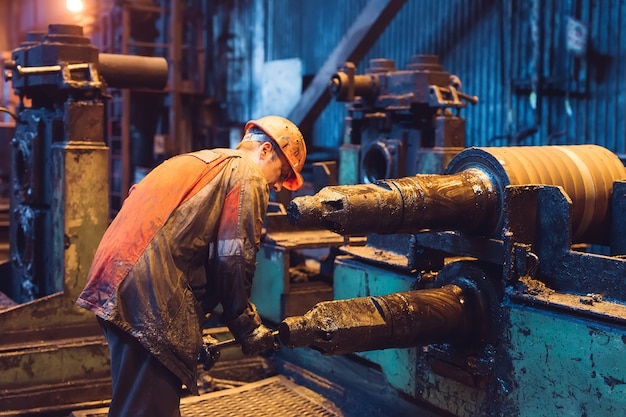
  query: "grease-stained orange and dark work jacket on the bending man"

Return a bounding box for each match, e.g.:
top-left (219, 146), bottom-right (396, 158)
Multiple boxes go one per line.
top-left (77, 149), bottom-right (269, 394)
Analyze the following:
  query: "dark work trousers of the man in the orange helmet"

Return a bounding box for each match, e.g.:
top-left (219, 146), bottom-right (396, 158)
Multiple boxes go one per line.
top-left (98, 318), bottom-right (182, 417)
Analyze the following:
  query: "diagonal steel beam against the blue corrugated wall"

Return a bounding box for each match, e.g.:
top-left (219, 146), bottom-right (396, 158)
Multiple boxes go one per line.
top-left (289, 0), bottom-right (406, 129)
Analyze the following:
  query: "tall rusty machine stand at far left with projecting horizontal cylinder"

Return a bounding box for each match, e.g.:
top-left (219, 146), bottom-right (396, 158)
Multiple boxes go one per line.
top-left (0, 25), bottom-right (167, 415)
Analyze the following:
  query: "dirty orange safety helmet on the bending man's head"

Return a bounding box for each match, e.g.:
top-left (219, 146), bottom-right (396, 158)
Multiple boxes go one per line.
top-left (244, 116), bottom-right (306, 191)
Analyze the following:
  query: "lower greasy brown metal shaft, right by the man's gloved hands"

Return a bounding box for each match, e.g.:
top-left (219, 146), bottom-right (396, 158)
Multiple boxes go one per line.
top-left (278, 281), bottom-right (478, 355)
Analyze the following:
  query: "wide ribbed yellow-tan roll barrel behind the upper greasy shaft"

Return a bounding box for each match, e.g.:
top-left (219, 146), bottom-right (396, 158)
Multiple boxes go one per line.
top-left (446, 145), bottom-right (626, 243)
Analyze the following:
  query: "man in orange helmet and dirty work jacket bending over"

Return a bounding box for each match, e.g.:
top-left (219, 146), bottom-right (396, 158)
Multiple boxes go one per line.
top-left (77, 116), bottom-right (306, 417)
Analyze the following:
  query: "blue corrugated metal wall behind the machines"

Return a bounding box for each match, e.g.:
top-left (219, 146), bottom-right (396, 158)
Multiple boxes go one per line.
top-left (265, 0), bottom-right (626, 153)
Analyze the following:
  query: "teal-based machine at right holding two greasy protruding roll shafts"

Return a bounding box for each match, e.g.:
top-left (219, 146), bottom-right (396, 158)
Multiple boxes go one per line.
top-left (279, 145), bottom-right (626, 416)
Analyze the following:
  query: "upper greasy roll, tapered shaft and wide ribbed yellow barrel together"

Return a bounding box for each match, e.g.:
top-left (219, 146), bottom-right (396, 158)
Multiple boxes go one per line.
top-left (287, 145), bottom-right (626, 243)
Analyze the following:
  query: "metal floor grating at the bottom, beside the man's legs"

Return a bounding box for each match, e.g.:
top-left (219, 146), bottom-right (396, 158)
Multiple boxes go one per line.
top-left (72, 375), bottom-right (344, 417)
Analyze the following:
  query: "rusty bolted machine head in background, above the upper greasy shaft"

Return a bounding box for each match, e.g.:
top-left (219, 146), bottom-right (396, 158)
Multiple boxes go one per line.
top-left (328, 55), bottom-right (478, 184)
